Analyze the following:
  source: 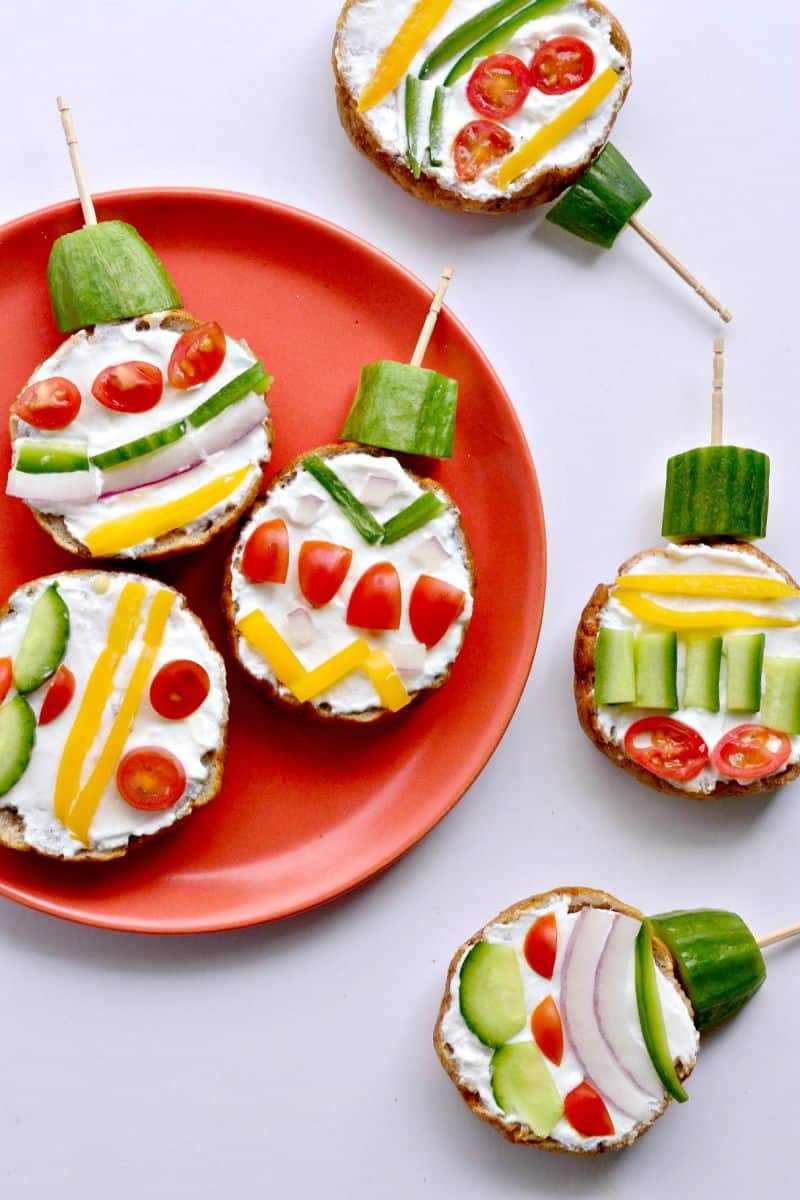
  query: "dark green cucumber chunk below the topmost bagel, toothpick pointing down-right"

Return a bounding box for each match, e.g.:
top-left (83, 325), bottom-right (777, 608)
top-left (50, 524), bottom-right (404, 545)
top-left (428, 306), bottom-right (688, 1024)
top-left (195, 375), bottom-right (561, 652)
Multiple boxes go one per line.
top-left (547, 142), bottom-right (652, 250)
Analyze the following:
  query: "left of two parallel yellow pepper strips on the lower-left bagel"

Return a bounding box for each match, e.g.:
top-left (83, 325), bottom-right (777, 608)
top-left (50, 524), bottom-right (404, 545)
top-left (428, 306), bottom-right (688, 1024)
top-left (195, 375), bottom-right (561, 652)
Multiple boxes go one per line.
top-left (53, 582), bottom-right (148, 824)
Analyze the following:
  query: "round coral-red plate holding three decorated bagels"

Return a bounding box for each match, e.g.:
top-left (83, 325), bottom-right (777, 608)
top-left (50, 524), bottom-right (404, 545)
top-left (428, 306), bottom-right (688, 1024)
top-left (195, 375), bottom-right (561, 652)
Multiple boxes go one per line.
top-left (0, 188), bottom-right (545, 934)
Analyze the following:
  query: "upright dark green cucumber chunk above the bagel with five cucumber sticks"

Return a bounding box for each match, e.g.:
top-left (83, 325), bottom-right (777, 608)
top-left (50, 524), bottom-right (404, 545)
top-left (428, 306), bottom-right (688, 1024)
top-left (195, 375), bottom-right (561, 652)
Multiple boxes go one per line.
top-left (661, 446), bottom-right (770, 539)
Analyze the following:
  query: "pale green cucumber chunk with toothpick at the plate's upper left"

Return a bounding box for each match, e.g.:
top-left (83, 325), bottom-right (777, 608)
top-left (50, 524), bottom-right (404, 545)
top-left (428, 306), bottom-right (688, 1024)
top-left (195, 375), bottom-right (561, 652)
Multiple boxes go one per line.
top-left (47, 221), bottom-right (181, 334)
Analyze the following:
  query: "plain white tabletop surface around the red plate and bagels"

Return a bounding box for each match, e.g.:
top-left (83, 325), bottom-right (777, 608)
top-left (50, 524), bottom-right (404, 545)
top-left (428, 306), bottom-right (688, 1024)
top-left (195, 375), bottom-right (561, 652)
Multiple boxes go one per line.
top-left (0, 0), bottom-right (800, 1200)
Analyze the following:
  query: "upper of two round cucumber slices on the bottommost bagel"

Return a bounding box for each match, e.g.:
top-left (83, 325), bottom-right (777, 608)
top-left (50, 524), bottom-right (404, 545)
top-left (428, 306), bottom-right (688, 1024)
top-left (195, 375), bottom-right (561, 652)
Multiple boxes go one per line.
top-left (458, 942), bottom-right (525, 1046)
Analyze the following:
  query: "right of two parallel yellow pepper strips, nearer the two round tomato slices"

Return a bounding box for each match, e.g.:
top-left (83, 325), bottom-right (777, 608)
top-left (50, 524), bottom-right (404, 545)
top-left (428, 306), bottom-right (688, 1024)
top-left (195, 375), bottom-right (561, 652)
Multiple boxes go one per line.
top-left (65, 588), bottom-right (175, 846)
